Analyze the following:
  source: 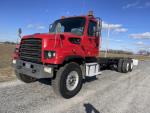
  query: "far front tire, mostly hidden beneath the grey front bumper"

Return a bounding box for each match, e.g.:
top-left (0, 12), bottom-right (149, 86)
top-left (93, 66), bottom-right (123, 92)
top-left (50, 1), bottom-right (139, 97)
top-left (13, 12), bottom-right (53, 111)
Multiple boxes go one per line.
top-left (16, 72), bottom-right (36, 83)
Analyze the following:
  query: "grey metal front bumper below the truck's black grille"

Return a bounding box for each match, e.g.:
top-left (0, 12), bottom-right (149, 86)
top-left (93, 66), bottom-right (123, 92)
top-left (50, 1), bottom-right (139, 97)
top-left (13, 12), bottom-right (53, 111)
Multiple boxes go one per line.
top-left (13, 60), bottom-right (54, 79)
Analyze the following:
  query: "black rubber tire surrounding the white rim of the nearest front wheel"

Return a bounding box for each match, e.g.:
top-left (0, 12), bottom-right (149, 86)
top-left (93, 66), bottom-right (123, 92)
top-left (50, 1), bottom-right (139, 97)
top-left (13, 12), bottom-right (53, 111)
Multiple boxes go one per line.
top-left (52, 62), bottom-right (82, 99)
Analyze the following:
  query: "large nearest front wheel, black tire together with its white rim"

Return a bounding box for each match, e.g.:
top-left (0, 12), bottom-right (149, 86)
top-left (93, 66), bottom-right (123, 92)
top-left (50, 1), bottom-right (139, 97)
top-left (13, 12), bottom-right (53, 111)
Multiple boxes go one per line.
top-left (52, 62), bottom-right (82, 99)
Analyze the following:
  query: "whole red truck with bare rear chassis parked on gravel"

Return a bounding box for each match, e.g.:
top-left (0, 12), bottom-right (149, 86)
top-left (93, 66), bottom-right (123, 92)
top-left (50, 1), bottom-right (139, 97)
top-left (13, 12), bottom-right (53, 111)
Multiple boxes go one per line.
top-left (13, 12), bottom-right (133, 98)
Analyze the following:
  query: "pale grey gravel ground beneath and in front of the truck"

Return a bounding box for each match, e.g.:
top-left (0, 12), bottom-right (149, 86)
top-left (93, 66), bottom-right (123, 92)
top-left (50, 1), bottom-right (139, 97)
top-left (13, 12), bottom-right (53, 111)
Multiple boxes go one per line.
top-left (0, 61), bottom-right (150, 113)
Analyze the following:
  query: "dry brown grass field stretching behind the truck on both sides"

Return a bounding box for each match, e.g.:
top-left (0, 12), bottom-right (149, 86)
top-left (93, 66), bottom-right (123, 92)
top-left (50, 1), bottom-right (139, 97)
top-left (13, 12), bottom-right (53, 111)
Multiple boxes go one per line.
top-left (0, 44), bottom-right (150, 82)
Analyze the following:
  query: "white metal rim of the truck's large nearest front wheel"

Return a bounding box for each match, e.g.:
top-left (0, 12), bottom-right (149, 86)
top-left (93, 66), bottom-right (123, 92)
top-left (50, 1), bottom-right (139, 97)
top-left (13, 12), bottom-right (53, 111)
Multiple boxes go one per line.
top-left (66, 71), bottom-right (79, 91)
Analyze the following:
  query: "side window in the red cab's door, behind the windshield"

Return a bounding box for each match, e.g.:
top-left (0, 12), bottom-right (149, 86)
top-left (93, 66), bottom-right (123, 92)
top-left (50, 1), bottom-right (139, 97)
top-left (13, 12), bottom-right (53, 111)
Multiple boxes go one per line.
top-left (88, 21), bottom-right (96, 37)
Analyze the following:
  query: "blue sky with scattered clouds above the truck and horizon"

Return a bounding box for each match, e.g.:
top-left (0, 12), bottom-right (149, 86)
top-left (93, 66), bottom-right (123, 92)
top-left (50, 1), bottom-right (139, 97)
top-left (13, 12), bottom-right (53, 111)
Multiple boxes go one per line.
top-left (0, 0), bottom-right (150, 52)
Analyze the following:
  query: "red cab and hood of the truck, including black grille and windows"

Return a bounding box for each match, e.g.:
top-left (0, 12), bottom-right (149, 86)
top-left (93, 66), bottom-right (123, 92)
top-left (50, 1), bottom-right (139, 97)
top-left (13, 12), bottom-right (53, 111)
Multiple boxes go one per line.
top-left (19, 15), bottom-right (100, 65)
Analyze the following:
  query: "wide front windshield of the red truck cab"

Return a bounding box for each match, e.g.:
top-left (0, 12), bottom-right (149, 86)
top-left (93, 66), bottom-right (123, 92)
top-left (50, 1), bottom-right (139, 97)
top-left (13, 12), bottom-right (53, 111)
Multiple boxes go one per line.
top-left (49, 17), bottom-right (85, 36)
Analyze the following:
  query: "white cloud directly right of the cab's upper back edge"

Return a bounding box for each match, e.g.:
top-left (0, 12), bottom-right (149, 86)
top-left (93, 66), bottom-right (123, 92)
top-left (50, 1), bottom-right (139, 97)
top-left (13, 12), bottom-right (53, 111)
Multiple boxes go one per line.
top-left (102, 22), bottom-right (128, 33)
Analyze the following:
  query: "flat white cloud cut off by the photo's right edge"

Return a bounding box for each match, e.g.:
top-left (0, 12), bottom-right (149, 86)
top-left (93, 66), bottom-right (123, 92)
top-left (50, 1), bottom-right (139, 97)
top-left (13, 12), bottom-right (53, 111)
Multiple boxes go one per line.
top-left (129, 32), bottom-right (150, 39)
